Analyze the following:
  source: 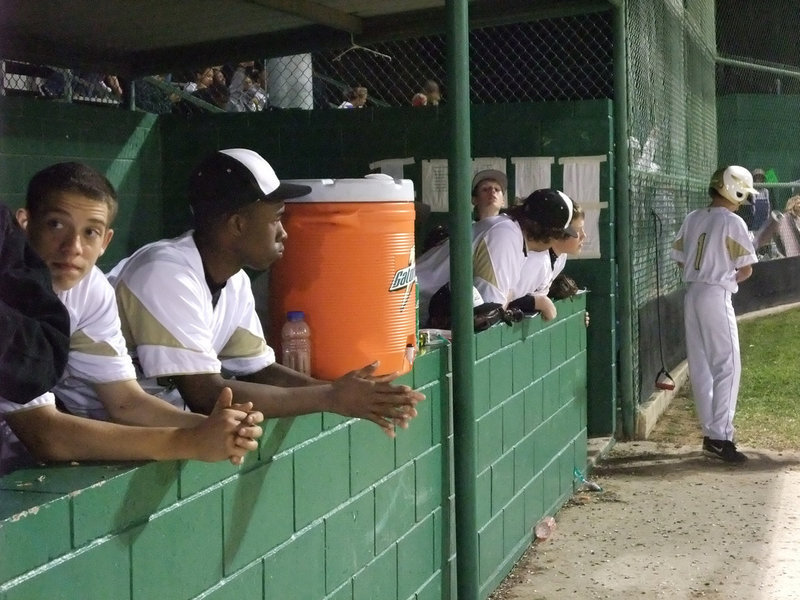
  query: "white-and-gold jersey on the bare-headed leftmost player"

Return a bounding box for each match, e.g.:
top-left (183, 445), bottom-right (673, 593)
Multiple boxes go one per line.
top-left (52, 267), bottom-right (136, 420)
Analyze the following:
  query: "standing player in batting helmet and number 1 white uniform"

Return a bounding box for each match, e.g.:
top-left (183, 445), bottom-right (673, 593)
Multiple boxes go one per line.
top-left (671, 166), bottom-right (758, 463)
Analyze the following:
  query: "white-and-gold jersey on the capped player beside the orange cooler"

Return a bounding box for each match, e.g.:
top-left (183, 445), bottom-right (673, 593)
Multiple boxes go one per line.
top-left (110, 231), bottom-right (275, 403)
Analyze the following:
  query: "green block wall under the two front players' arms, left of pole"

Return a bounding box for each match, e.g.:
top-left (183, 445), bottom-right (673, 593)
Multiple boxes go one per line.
top-left (0, 351), bottom-right (451, 600)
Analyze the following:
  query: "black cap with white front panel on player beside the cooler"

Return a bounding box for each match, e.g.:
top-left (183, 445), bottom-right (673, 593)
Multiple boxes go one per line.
top-left (189, 148), bottom-right (311, 217)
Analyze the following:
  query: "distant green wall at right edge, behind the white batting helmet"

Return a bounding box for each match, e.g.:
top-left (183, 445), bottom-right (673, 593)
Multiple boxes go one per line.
top-left (717, 94), bottom-right (800, 210)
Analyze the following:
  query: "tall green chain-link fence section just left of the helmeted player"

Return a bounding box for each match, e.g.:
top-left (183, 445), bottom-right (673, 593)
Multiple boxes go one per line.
top-left (626, 0), bottom-right (717, 400)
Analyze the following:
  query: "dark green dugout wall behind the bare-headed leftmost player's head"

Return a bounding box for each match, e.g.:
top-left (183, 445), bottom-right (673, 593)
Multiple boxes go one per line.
top-left (0, 97), bottom-right (164, 268)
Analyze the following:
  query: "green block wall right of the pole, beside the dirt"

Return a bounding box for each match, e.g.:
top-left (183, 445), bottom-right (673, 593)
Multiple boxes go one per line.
top-left (472, 294), bottom-right (587, 597)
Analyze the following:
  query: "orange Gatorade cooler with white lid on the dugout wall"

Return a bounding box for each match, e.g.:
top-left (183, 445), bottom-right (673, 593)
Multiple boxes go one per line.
top-left (269, 174), bottom-right (417, 379)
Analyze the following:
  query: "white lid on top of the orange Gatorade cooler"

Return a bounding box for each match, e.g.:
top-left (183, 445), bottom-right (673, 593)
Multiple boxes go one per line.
top-left (281, 173), bottom-right (414, 204)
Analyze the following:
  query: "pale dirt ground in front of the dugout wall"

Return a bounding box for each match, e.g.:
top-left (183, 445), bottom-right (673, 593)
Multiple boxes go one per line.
top-left (490, 398), bottom-right (800, 600)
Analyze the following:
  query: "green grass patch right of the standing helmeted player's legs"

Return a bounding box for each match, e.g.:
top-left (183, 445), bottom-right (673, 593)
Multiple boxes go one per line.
top-left (734, 308), bottom-right (800, 450)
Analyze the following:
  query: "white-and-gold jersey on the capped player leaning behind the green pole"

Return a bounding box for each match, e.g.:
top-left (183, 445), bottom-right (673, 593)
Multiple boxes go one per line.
top-left (416, 215), bottom-right (526, 322)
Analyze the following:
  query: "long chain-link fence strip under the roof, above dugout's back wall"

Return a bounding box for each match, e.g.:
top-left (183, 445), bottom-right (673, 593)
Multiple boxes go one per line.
top-left (2, 11), bottom-right (613, 113)
